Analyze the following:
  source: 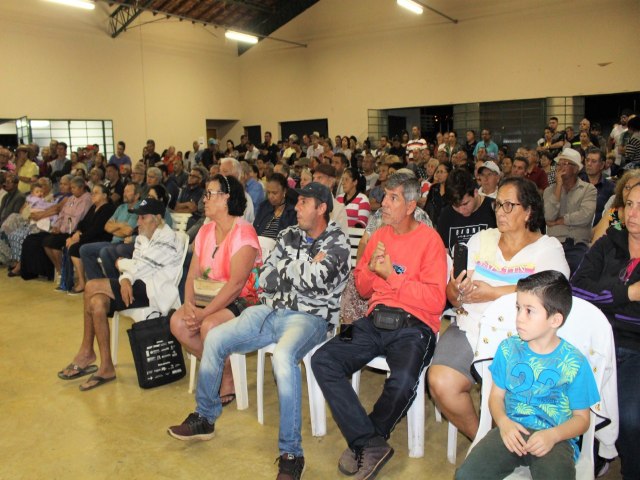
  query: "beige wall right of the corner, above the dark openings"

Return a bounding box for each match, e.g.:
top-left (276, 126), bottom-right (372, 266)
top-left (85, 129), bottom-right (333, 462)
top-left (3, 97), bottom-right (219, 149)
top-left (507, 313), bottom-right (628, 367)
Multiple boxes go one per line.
top-left (241, 0), bottom-right (640, 141)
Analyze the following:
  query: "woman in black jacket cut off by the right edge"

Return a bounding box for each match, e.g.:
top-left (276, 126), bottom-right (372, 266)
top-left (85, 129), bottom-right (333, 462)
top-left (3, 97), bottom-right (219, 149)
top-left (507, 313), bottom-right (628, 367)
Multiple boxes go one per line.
top-left (571, 182), bottom-right (640, 480)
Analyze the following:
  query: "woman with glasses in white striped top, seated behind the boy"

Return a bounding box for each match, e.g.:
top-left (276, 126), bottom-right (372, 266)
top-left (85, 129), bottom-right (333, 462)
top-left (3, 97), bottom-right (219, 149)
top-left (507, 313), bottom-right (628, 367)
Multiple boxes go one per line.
top-left (429, 177), bottom-right (569, 440)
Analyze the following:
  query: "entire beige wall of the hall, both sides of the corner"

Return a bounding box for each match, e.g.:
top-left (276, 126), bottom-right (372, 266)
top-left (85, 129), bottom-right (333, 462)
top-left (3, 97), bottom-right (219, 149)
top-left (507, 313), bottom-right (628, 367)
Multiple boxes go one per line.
top-left (0, 0), bottom-right (640, 152)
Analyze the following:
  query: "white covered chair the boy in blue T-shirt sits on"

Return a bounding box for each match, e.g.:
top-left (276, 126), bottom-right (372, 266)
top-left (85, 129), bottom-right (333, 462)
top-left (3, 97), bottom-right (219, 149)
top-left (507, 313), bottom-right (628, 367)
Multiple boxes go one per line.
top-left (467, 293), bottom-right (618, 480)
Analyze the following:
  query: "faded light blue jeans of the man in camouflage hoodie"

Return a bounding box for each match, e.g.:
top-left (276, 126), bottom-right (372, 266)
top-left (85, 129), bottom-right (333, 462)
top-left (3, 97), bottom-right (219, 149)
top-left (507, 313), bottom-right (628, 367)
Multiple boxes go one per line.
top-left (196, 305), bottom-right (327, 456)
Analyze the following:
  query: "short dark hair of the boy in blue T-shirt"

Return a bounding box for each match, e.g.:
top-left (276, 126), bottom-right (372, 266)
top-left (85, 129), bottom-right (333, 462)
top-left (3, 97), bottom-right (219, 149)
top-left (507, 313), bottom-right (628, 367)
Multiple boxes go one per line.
top-left (517, 270), bottom-right (573, 326)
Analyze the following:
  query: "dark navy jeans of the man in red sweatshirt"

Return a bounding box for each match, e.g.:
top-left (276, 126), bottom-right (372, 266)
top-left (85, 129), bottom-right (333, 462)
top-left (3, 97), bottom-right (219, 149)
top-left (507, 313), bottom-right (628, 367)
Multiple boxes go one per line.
top-left (311, 317), bottom-right (436, 449)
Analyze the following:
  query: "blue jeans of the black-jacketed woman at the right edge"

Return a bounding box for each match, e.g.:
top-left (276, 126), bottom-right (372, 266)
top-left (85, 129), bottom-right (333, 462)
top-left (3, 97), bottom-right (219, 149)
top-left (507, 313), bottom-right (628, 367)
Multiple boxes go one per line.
top-left (616, 347), bottom-right (640, 480)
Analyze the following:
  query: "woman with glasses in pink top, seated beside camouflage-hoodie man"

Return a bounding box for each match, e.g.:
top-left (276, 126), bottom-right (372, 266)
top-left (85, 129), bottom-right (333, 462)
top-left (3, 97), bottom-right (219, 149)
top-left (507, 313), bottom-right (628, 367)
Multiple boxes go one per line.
top-left (171, 174), bottom-right (262, 406)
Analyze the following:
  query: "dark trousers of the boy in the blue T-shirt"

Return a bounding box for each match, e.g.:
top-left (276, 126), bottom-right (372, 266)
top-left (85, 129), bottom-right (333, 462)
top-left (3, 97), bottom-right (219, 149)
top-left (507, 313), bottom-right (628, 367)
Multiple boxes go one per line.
top-left (455, 428), bottom-right (576, 480)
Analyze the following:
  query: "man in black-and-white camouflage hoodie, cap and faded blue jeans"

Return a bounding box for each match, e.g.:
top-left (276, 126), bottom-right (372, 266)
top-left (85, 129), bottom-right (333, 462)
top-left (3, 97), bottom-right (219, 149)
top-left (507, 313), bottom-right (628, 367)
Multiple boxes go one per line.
top-left (168, 182), bottom-right (350, 480)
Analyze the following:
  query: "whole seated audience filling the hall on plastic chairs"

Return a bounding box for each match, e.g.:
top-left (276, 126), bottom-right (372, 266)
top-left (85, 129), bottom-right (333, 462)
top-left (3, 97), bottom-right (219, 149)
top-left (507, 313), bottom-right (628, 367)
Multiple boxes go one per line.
top-left (0, 111), bottom-right (640, 480)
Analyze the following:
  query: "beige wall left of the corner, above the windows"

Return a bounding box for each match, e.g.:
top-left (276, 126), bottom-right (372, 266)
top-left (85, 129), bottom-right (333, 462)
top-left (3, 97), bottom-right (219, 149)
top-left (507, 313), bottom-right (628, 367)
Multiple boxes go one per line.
top-left (0, 0), bottom-right (241, 158)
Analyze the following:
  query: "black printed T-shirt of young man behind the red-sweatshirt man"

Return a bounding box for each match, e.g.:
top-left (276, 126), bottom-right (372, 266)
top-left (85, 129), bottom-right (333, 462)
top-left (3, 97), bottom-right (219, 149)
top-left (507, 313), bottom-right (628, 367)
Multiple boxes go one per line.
top-left (438, 197), bottom-right (496, 255)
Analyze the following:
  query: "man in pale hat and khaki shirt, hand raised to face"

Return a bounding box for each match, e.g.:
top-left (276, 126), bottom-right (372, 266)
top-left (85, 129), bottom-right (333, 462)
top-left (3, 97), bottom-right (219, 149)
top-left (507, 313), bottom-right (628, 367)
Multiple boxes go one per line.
top-left (543, 148), bottom-right (598, 275)
